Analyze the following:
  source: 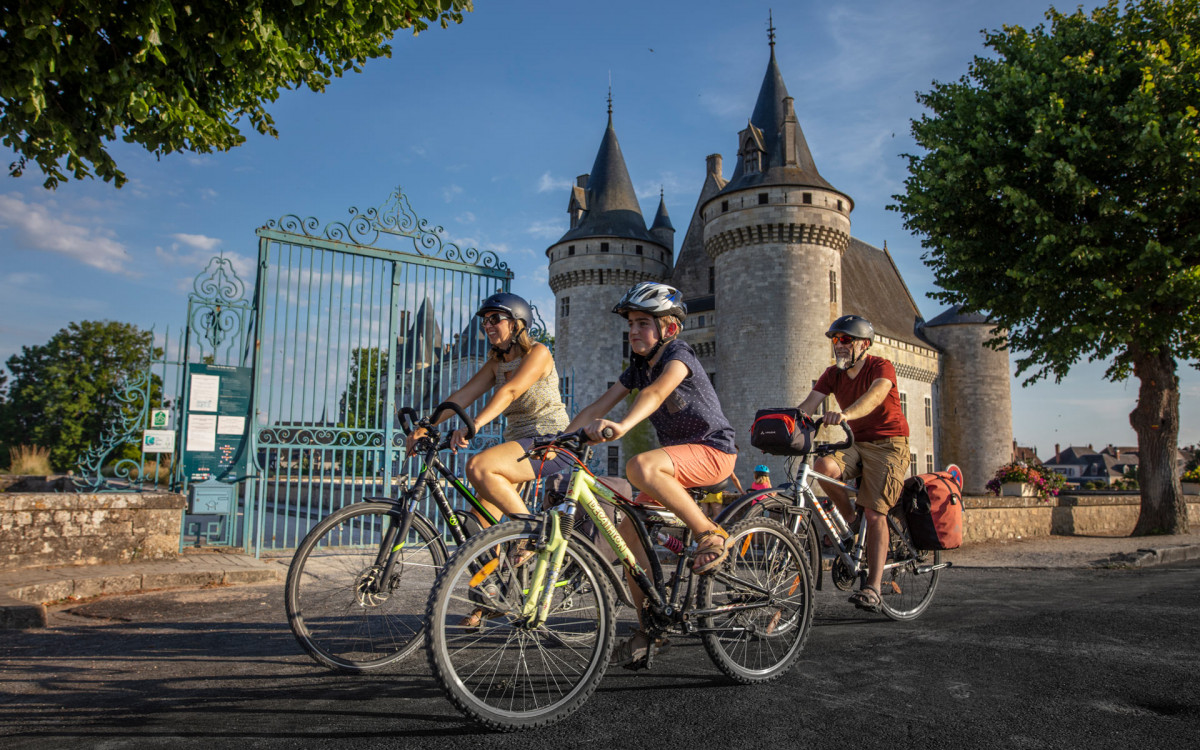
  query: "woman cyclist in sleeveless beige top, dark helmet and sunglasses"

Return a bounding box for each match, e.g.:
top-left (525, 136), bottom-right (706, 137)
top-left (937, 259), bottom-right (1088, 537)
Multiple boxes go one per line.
top-left (408, 292), bottom-right (569, 524)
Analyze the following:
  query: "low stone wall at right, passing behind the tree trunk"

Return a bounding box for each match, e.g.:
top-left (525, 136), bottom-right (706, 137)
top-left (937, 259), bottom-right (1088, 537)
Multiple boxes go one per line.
top-left (962, 493), bottom-right (1200, 545)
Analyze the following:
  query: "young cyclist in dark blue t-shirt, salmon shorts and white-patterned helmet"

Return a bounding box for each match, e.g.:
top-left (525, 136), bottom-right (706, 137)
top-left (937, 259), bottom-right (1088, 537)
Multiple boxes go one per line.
top-left (568, 281), bottom-right (737, 666)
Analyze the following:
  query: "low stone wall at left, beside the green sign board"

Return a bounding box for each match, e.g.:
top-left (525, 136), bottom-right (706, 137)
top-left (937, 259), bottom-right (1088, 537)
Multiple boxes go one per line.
top-left (0, 492), bottom-right (187, 570)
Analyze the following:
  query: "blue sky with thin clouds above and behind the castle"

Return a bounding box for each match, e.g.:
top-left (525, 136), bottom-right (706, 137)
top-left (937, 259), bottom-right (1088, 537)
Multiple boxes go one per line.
top-left (0, 0), bottom-right (1200, 457)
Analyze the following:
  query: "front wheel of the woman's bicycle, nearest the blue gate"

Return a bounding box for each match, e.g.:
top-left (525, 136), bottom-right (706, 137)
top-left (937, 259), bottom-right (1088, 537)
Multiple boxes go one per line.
top-left (284, 503), bottom-right (445, 673)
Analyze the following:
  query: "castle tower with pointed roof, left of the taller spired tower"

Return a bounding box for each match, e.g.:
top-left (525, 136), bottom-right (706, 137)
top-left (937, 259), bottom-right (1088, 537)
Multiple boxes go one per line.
top-left (546, 100), bottom-right (674, 469)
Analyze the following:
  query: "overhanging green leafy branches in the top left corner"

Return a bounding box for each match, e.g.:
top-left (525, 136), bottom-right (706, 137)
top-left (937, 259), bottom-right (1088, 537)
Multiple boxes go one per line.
top-left (0, 0), bottom-right (473, 188)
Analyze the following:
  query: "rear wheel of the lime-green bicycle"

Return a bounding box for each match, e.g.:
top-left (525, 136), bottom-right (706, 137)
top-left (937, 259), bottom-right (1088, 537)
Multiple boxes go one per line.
top-left (696, 518), bottom-right (814, 684)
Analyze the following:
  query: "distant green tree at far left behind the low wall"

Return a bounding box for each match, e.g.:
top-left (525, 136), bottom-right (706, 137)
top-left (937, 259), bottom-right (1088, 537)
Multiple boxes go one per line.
top-left (0, 320), bottom-right (162, 470)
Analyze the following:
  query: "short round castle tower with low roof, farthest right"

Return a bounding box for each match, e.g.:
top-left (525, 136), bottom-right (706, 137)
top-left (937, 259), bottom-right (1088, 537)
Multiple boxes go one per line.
top-left (919, 305), bottom-right (1013, 494)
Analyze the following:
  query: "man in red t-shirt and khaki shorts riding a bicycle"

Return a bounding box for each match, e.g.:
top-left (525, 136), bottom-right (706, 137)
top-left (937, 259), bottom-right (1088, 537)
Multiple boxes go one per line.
top-left (799, 316), bottom-right (908, 612)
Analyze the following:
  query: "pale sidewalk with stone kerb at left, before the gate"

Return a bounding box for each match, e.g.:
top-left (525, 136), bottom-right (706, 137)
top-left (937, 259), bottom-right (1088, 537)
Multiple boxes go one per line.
top-left (0, 551), bottom-right (289, 630)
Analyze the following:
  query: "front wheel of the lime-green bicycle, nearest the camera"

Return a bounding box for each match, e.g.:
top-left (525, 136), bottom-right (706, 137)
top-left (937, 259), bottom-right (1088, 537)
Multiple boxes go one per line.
top-left (425, 521), bottom-right (616, 731)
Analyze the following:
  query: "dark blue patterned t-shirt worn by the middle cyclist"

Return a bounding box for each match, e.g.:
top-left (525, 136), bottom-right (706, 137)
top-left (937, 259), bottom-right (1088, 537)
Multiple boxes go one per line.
top-left (620, 338), bottom-right (737, 454)
